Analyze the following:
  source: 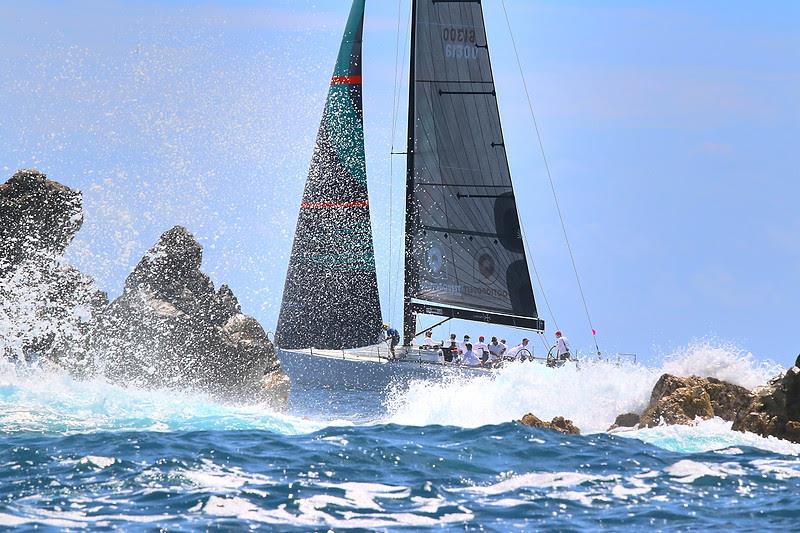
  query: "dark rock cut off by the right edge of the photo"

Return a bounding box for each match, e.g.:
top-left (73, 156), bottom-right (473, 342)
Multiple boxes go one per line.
top-left (733, 366), bottom-right (800, 443)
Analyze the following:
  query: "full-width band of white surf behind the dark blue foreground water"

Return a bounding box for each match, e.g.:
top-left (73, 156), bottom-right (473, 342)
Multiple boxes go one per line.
top-left (0, 342), bottom-right (788, 455)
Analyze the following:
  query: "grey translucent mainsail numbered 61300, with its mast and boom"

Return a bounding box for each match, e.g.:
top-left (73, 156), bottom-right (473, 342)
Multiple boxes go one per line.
top-left (404, 0), bottom-right (544, 341)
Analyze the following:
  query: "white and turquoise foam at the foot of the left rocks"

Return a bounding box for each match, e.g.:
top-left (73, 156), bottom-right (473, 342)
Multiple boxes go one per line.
top-left (0, 362), bottom-right (328, 436)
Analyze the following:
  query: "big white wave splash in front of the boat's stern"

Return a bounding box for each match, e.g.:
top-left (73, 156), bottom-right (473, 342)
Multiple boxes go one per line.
top-left (388, 342), bottom-right (780, 433)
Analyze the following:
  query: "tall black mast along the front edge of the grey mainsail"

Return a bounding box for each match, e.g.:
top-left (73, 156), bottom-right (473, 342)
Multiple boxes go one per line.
top-left (403, 0), bottom-right (418, 346)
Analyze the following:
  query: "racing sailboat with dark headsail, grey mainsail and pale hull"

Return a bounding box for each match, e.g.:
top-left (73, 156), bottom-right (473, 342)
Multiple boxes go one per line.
top-left (276, 0), bottom-right (545, 388)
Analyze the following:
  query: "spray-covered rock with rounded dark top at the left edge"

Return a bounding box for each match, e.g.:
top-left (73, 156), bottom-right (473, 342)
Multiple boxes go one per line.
top-left (0, 170), bottom-right (108, 366)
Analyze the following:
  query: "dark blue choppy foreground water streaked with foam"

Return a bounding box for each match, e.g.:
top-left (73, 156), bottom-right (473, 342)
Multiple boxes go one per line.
top-left (0, 424), bottom-right (800, 531)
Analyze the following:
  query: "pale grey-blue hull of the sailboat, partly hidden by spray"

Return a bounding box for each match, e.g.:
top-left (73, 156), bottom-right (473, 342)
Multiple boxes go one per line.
top-left (278, 345), bottom-right (492, 391)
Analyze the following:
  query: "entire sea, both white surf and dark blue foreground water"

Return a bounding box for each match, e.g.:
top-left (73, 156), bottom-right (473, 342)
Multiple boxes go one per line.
top-left (0, 343), bottom-right (800, 531)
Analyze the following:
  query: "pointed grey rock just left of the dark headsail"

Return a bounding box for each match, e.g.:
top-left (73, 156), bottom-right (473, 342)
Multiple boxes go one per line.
top-left (90, 226), bottom-right (288, 404)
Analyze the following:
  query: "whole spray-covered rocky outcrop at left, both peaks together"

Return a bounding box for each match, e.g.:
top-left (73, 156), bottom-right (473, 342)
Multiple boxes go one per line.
top-left (0, 170), bottom-right (289, 408)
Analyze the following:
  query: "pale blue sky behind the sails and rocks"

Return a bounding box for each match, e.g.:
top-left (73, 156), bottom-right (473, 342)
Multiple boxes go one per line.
top-left (0, 0), bottom-right (800, 364)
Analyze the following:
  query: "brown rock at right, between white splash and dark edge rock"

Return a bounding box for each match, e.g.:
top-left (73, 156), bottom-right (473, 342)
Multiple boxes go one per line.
top-left (640, 374), bottom-right (752, 427)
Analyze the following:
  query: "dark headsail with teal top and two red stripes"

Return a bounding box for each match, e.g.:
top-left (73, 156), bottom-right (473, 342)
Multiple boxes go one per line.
top-left (276, 0), bottom-right (381, 349)
